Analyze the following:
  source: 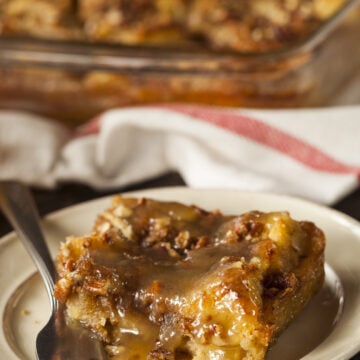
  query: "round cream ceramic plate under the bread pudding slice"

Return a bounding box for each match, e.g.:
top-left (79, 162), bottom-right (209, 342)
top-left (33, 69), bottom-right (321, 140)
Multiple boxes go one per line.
top-left (0, 188), bottom-right (360, 360)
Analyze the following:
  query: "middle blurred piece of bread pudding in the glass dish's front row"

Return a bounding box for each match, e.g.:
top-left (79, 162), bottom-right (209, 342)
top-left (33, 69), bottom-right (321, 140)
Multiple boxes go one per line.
top-left (79, 0), bottom-right (185, 44)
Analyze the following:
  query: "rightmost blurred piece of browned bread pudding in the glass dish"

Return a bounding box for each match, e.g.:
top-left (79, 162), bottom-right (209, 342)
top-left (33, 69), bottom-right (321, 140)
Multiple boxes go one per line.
top-left (188, 0), bottom-right (344, 52)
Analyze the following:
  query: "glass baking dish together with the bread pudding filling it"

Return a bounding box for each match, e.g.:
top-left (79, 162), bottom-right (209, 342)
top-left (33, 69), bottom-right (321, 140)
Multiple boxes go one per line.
top-left (0, 0), bottom-right (354, 122)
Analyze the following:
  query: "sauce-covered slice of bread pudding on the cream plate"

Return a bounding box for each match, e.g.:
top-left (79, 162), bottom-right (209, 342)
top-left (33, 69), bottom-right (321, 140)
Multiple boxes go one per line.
top-left (55, 196), bottom-right (325, 360)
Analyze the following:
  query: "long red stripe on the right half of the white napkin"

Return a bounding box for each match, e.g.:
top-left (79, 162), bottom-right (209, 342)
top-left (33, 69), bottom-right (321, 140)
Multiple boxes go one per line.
top-left (164, 105), bottom-right (360, 177)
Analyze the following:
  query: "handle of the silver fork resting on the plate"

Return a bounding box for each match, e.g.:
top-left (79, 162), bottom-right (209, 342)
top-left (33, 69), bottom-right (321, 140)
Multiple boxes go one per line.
top-left (0, 181), bottom-right (56, 308)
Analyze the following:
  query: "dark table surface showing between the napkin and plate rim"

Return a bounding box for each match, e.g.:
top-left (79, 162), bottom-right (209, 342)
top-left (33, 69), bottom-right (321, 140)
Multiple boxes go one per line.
top-left (0, 173), bottom-right (360, 360)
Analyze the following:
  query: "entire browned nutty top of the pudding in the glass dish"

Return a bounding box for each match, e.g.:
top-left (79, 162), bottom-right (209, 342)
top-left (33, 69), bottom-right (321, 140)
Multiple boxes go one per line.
top-left (0, 0), bottom-right (345, 52)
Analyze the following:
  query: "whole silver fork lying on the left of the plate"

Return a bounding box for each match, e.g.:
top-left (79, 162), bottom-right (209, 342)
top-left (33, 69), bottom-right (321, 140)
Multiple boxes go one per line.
top-left (0, 181), bottom-right (106, 360)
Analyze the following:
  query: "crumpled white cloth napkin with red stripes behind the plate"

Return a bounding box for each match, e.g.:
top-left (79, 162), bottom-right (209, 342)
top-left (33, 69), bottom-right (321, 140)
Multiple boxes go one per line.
top-left (0, 104), bottom-right (360, 204)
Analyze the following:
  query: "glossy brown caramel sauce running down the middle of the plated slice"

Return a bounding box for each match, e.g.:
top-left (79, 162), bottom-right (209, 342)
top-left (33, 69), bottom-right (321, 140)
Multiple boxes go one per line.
top-left (90, 236), bottom-right (262, 359)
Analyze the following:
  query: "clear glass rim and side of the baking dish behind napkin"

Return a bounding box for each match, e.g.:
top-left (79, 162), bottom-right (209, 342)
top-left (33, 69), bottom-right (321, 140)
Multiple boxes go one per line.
top-left (0, 0), bottom-right (360, 125)
